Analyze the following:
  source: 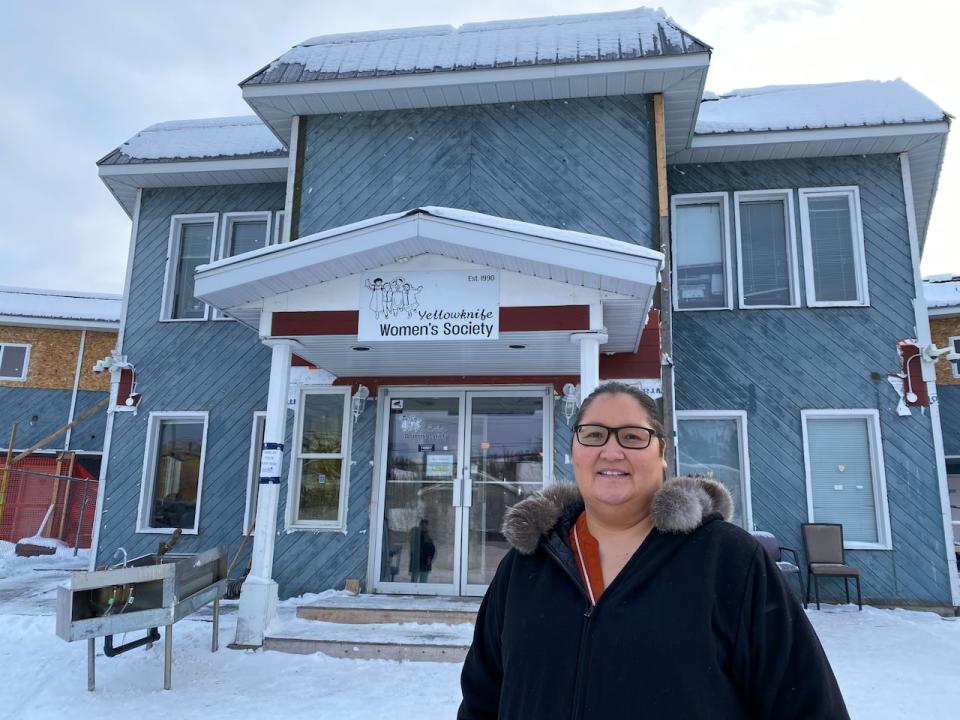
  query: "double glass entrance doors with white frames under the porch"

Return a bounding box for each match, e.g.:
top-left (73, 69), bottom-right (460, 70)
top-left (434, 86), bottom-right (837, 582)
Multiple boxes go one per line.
top-left (375, 389), bottom-right (552, 595)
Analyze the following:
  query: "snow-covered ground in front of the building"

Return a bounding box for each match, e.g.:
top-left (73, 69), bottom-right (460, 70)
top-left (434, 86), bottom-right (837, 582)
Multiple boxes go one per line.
top-left (0, 543), bottom-right (960, 720)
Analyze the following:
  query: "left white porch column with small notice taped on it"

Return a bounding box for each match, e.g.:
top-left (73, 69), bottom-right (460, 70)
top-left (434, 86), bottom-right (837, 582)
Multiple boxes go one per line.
top-left (235, 340), bottom-right (297, 646)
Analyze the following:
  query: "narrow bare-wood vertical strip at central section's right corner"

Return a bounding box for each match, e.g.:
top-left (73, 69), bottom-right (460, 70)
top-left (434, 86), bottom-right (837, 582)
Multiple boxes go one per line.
top-left (653, 93), bottom-right (677, 477)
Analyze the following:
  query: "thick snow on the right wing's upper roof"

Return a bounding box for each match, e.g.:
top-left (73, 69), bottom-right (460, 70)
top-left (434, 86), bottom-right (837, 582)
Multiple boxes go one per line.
top-left (696, 79), bottom-right (945, 134)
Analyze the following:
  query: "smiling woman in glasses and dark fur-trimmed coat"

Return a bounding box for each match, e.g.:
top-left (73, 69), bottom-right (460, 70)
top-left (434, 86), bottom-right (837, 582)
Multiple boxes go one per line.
top-left (458, 383), bottom-right (848, 720)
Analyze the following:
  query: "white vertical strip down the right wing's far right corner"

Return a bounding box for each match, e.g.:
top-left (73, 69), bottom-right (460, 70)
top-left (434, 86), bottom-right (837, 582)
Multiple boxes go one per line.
top-left (900, 152), bottom-right (960, 607)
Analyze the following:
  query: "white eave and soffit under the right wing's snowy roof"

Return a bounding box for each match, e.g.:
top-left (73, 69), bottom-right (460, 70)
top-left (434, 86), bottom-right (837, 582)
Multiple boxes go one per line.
top-left (667, 121), bottom-right (950, 248)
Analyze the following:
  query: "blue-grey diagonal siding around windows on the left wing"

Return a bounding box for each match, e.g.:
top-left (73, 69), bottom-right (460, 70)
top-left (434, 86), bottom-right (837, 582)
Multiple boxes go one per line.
top-left (97, 184), bottom-right (285, 562)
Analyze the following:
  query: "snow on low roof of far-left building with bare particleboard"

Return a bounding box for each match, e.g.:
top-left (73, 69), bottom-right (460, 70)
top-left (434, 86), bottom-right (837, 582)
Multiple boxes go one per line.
top-left (0, 287), bottom-right (123, 324)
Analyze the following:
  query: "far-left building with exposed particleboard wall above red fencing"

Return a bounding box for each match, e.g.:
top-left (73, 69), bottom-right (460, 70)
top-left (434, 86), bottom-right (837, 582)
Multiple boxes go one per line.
top-left (0, 287), bottom-right (121, 547)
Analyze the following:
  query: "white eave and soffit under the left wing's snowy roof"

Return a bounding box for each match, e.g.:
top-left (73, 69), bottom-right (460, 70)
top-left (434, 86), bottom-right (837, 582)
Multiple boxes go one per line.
top-left (97, 157), bottom-right (288, 217)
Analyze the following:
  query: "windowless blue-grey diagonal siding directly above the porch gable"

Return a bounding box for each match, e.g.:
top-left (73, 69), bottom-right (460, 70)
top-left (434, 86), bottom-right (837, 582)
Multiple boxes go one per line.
top-left (299, 96), bottom-right (659, 247)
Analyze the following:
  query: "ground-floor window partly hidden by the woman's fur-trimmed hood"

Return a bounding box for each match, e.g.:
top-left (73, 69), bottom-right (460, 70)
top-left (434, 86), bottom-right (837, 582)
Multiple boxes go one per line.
top-left (677, 410), bottom-right (753, 530)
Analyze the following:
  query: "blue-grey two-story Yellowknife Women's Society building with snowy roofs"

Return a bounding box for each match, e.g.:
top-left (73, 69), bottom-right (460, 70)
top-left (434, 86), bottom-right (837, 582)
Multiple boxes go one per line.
top-left (88, 9), bottom-right (960, 644)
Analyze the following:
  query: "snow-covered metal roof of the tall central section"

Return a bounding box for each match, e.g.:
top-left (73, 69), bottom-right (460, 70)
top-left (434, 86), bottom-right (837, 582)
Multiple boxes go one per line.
top-left (248, 8), bottom-right (710, 85)
